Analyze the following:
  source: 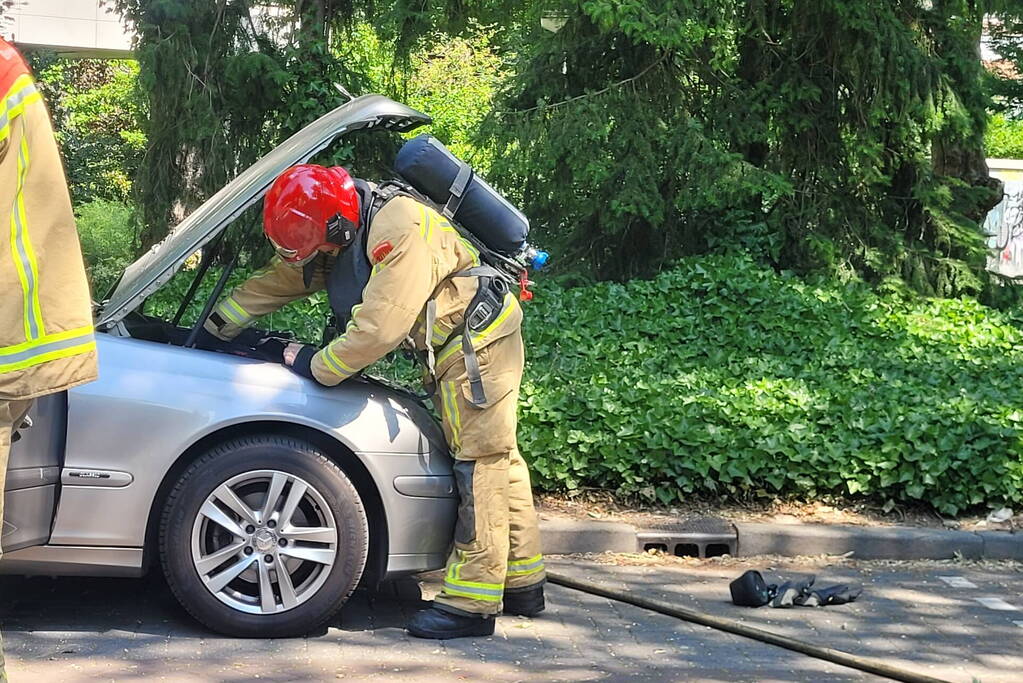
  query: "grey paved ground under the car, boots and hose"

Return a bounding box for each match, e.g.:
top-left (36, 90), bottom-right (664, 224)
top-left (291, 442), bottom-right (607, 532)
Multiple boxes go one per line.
top-left (0, 558), bottom-right (1023, 683)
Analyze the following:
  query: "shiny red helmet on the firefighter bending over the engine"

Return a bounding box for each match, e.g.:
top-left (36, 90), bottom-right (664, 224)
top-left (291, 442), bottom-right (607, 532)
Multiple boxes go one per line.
top-left (263, 164), bottom-right (359, 262)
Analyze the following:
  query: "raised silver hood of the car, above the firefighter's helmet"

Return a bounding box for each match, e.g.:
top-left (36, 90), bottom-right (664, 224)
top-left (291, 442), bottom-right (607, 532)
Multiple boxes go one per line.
top-left (96, 95), bottom-right (430, 328)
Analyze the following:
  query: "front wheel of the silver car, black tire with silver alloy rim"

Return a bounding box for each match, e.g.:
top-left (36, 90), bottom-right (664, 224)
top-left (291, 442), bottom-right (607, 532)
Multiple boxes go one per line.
top-left (160, 435), bottom-right (369, 638)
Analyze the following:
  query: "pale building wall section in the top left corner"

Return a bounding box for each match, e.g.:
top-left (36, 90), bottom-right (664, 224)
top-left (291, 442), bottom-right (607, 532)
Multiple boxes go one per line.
top-left (0, 0), bottom-right (133, 57)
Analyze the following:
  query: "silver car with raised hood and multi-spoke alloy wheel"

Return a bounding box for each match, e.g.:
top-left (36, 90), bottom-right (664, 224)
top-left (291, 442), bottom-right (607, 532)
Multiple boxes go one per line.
top-left (0, 95), bottom-right (457, 637)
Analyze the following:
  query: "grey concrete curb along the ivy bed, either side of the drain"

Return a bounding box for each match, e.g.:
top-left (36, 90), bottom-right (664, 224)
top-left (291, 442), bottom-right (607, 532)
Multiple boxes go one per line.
top-left (540, 518), bottom-right (1023, 561)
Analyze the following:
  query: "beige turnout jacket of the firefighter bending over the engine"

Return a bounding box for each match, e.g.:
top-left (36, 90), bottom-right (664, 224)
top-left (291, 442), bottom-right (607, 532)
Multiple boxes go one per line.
top-left (206, 196), bottom-right (522, 385)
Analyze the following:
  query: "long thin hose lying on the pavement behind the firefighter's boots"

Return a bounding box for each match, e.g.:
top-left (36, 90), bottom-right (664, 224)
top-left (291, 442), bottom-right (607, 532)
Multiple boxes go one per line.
top-left (547, 571), bottom-right (947, 683)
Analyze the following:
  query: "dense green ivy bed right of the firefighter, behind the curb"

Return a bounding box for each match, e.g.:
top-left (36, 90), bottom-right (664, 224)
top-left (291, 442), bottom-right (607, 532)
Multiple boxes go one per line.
top-left (520, 257), bottom-right (1023, 514)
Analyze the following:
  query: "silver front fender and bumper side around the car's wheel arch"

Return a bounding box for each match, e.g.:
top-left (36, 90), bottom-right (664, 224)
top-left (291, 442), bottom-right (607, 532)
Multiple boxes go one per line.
top-left (50, 334), bottom-right (455, 573)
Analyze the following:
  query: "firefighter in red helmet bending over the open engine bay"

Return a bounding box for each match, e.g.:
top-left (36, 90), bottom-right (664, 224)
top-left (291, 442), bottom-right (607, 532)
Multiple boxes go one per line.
top-left (204, 165), bottom-right (545, 638)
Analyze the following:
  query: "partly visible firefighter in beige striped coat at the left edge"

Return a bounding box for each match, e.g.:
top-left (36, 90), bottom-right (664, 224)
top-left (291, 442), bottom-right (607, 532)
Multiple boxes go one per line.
top-left (0, 38), bottom-right (96, 681)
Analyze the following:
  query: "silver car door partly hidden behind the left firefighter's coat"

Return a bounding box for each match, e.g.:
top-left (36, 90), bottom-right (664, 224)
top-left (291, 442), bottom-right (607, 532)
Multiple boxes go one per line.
top-left (0, 392), bottom-right (68, 552)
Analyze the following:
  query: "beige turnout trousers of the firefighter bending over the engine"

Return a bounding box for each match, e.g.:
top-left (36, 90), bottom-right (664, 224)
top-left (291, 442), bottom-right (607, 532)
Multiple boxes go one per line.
top-left (434, 328), bottom-right (545, 614)
